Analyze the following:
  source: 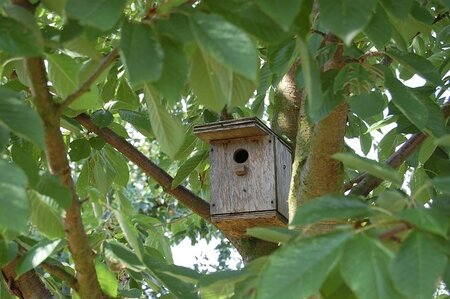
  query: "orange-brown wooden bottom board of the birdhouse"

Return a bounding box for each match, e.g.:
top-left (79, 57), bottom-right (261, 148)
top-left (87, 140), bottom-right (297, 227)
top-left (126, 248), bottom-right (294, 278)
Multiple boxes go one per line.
top-left (211, 210), bottom-right (287, 238)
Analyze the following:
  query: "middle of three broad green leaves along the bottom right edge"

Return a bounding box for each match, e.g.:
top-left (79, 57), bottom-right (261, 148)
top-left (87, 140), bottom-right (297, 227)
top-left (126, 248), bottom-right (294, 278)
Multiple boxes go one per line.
top-left (340, 234), bottom-right (402, 299)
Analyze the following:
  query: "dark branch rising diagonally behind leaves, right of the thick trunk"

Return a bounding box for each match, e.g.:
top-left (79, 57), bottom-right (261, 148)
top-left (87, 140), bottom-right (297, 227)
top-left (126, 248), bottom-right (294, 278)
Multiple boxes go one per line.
top-left (350, 104), bottom-right (450, 196)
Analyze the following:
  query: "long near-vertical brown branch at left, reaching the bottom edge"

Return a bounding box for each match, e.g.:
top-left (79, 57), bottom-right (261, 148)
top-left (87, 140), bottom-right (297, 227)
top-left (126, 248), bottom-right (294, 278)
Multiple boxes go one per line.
top-left (25, 58), bottom-right (104, 299)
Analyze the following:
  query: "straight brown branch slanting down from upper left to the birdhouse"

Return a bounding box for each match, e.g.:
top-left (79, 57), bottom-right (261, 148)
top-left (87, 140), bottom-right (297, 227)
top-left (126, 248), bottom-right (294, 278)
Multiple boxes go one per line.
top-left (75, 114), bottom-right (211, 222)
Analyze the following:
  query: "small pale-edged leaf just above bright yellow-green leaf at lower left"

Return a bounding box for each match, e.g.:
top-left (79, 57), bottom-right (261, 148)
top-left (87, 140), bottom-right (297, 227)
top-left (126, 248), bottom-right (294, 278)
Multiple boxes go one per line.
top-left (104, 240), bottom-right (145, 272)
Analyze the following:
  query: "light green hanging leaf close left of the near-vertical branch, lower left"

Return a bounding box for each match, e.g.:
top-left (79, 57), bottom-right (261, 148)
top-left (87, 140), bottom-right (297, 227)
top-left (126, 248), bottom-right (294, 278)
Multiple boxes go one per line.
top-left (28, 191), bottom-right (65, 240)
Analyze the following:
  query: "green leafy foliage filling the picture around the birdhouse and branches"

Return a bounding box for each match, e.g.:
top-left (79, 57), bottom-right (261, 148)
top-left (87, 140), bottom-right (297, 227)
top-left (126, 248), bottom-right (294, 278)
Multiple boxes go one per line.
top-left (0, 0), bottom-right (450, 298)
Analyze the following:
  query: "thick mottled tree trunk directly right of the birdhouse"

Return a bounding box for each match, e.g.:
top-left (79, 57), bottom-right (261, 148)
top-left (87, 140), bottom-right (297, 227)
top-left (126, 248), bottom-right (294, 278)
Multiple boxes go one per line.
top-left (289, 35), bottom-right (348, 234)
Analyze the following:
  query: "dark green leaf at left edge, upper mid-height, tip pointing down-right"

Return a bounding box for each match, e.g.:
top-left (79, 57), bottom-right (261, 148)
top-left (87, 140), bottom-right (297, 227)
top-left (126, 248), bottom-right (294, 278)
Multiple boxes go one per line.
top-left (0, 91), bottom-right (45, 149)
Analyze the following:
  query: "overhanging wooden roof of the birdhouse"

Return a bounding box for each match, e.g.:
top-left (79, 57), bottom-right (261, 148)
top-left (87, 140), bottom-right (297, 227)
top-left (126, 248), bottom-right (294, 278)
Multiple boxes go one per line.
top-left (194, 117), bottom-right (289, 147)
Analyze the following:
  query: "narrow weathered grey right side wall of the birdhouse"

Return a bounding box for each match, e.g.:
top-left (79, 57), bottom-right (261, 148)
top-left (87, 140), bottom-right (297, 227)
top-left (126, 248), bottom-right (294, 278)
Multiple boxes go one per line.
top-left (275, 138), bottom-right (292, 219)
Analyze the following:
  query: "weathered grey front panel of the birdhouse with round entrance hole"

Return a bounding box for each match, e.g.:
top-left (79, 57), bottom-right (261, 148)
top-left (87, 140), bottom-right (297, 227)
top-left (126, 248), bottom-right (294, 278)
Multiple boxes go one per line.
top-left (210, 136), bottom-right (276, 214)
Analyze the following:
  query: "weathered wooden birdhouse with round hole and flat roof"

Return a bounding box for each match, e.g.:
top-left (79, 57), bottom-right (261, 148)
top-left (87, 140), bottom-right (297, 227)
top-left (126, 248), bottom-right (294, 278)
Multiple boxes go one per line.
top-left (194, 117), bottom-right (292, 237)
